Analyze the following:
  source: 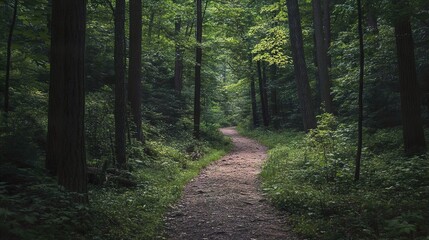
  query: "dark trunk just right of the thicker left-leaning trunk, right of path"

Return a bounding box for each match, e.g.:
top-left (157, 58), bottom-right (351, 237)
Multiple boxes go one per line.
top-left (312, 0), bottom-right (333, 113)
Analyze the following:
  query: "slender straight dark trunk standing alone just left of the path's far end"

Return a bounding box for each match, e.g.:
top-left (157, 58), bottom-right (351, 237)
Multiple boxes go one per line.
top-left (194, 0), bottom-right (203, 139)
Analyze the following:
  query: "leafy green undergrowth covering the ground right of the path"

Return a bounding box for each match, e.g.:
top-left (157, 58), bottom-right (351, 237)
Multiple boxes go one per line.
top-left (240, 114), bottom-right (429, 240)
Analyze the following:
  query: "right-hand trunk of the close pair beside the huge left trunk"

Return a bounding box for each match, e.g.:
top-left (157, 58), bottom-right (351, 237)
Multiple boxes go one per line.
top-left (128, 0), bottom-right (143, 142)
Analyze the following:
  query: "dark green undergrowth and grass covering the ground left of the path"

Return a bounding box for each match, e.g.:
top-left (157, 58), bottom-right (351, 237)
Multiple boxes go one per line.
top-left (0, 120), bottom-right (231, 240)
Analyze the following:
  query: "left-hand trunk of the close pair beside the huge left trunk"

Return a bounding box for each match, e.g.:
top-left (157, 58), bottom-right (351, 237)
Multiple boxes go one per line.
top-left (114, 0), bottom-right (127, 168)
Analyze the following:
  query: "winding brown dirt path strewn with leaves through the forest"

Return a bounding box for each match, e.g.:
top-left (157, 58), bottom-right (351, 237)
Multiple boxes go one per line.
top-left (166, 128), bottom-right (297, 240)
